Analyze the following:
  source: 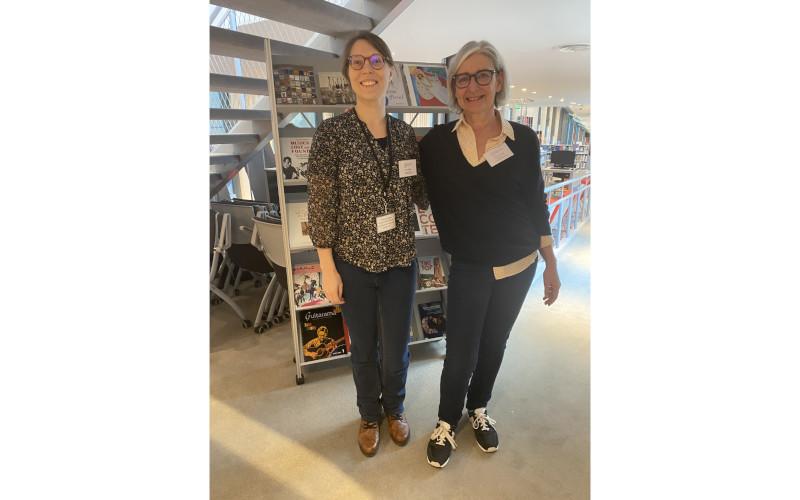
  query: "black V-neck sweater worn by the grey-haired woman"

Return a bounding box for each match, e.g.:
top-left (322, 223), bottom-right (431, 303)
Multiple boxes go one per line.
top-left (420, 122), bottom-right (551, 266)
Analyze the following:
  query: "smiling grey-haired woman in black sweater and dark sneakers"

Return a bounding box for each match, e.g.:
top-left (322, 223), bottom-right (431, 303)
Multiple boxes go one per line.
top-left (420, 41), bottom-right (561, 467)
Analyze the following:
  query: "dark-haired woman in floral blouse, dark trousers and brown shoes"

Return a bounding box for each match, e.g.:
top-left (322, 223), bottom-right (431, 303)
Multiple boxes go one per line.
top-left (308, 32), bottom-right (428, 456)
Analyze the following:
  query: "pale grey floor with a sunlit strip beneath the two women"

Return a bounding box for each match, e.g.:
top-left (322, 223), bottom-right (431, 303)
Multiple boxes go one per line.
top-left (211, 224), bottom-right (590, 500)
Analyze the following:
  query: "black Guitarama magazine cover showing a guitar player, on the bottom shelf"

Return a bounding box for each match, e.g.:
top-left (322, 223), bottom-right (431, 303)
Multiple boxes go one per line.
top-left (299, 306), bottom-right (347, 361)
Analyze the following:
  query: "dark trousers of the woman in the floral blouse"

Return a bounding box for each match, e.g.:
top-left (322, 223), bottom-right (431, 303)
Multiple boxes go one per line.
top-left (334, 255), bottom-right (417, 422)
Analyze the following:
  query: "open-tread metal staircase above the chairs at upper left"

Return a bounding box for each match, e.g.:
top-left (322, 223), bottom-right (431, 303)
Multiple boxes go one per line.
top-left (209, 0), bottom-right (413, 201)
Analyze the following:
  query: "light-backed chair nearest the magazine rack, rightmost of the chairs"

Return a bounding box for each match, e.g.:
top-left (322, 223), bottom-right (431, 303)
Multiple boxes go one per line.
top-left (252, 215), bottom-right (289, 330)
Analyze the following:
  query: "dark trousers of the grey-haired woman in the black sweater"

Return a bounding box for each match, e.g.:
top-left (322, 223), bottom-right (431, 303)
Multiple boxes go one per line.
top-left (439, 260), bottom-right (538, 429)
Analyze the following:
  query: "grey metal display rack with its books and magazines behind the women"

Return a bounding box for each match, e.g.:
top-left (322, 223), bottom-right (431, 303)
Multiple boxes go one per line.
top-left (265, 40), bottom-right (449, 384)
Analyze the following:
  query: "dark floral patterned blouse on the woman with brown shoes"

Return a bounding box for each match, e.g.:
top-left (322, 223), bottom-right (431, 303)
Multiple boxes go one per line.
top-left (308, 109), bottom-right (428, 273)
